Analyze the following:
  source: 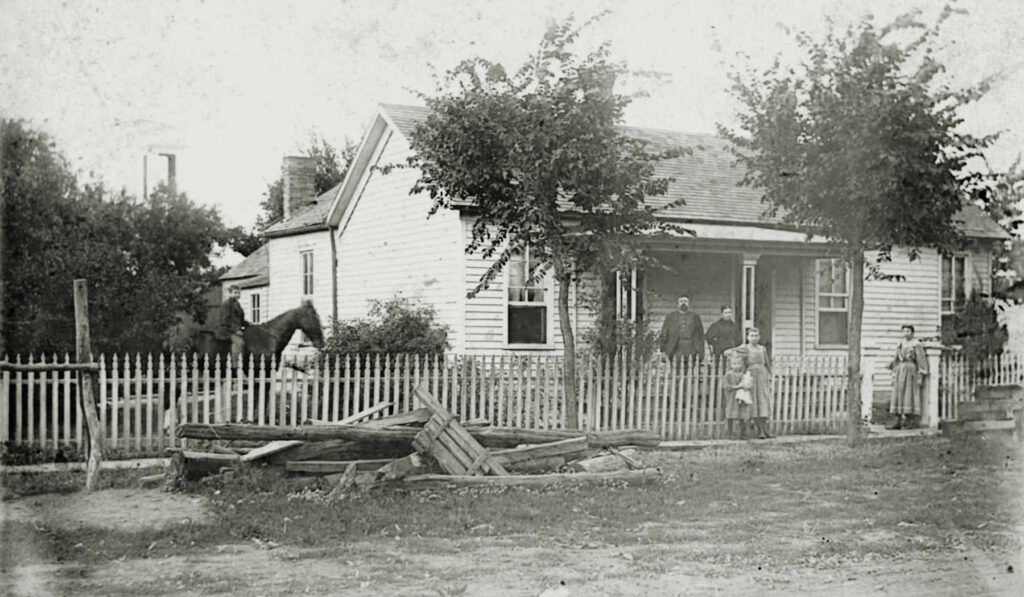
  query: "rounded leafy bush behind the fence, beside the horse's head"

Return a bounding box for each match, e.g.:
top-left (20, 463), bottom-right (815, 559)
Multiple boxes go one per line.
top-left (323, 297), bottom-right (450, 356)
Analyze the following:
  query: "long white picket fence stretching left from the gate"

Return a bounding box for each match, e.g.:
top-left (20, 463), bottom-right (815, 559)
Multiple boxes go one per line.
top-left (0, 354), bottom-right (846, 456)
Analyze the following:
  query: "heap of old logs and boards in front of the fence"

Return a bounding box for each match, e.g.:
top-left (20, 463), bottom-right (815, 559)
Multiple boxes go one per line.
top-left (165, 387), bottom-right (659, 489)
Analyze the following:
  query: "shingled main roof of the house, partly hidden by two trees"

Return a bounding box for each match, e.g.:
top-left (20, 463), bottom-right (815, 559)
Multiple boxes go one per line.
top-left (370, 103), bottom-right (1010, 239)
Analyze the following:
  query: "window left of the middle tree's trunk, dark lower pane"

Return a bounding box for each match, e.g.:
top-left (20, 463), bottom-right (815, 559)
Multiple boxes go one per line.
top-left (508, 247), bottom-right (551, 344)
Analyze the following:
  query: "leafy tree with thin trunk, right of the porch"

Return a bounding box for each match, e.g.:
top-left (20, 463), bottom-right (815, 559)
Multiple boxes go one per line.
top-left (722, 8), bottom-right (991, 439)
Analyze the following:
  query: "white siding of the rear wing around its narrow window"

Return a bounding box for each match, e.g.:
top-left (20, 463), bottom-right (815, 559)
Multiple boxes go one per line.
top-left (268, 230), bottom-right (334, 354)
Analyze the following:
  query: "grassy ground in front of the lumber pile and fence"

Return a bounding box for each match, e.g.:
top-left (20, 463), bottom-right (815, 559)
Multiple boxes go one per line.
top-left (3, 438), bottom-right (1024, 571)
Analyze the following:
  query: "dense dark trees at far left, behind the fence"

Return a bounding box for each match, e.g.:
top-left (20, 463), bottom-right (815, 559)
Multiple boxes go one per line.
top-left (0, 120), bottom-right (229, 353)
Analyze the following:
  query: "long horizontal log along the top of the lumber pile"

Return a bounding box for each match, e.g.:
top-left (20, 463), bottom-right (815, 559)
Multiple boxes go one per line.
top-left (177, 423), bottom-right (660, 454)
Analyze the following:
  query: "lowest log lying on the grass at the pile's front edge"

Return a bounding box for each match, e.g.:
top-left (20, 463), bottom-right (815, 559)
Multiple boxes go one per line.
top-left (394, 468), bottom-right (662, 489)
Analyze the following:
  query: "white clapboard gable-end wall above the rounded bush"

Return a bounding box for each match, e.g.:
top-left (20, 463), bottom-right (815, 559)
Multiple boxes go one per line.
top-left (337, 129), bottom-right (463, 351)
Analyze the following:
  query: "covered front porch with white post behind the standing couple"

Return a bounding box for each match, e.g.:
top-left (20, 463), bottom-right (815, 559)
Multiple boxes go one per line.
top-left (618, 224), bottom-right (850, 357)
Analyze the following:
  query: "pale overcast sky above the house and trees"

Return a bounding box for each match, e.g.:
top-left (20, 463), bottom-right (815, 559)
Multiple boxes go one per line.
top-left (0, 0), bottom-right (1024, 231)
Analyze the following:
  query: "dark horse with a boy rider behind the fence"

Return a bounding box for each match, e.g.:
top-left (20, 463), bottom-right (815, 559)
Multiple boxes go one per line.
top-left (196, 301), bottom-right (324, 365)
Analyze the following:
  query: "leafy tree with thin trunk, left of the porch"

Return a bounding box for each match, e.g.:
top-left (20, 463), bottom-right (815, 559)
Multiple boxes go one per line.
top-left (408, 19), bottom-right (676, 428)
